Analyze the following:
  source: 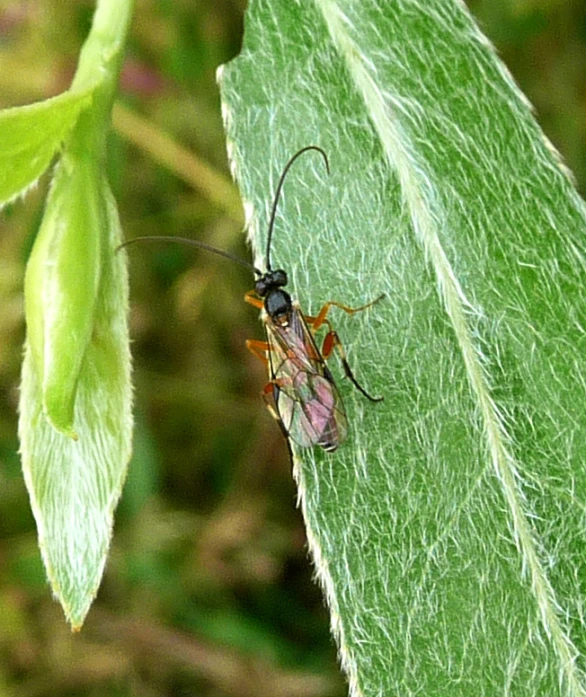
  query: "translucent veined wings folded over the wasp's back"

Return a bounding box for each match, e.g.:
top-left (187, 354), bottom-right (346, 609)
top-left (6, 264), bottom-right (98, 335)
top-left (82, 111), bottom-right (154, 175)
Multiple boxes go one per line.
top-left (265, 307), bottom-right (348, 452)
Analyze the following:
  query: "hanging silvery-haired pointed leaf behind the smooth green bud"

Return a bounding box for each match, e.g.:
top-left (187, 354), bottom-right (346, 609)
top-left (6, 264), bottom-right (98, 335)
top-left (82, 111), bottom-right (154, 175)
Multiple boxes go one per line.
top-left (19, 181), bottom-right (132, 628)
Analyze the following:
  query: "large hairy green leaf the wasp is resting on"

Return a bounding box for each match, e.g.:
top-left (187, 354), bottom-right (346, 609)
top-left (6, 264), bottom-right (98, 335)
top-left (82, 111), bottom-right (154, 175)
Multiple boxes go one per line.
top-left (221, 0), bottom-right (586, 697)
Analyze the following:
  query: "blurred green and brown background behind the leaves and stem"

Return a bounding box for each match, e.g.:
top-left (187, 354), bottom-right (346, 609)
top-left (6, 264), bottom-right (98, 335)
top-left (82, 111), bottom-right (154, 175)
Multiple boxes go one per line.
top-left (0, 0), bottom-right (586, 697)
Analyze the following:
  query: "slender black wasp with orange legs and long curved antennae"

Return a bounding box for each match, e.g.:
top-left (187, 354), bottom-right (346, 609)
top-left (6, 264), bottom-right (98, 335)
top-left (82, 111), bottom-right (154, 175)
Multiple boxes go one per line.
top-left (119, 145), bottom-right (383, 453)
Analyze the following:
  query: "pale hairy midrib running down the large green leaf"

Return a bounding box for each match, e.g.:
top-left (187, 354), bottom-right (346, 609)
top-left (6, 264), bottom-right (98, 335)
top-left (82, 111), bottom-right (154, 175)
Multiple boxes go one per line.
top-left (315, 0), bottom-right (586, 697)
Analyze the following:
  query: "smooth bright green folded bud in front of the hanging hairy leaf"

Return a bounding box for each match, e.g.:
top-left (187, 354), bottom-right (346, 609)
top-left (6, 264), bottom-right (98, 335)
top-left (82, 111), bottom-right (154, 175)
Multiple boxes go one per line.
top-left (25, 152), bottom-right (102, 437)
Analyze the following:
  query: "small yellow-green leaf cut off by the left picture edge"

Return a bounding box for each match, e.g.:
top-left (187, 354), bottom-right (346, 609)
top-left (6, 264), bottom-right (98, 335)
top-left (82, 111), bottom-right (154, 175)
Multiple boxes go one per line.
top-left (0, 92), bottom-right (91, 204)
